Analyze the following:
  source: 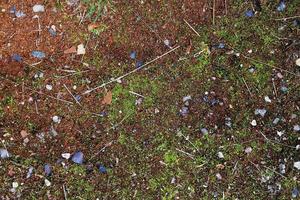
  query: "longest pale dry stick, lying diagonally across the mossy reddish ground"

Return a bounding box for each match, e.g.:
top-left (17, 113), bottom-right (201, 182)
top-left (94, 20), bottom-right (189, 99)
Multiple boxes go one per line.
top-left (83, 46), bottom-right (180, 95)
